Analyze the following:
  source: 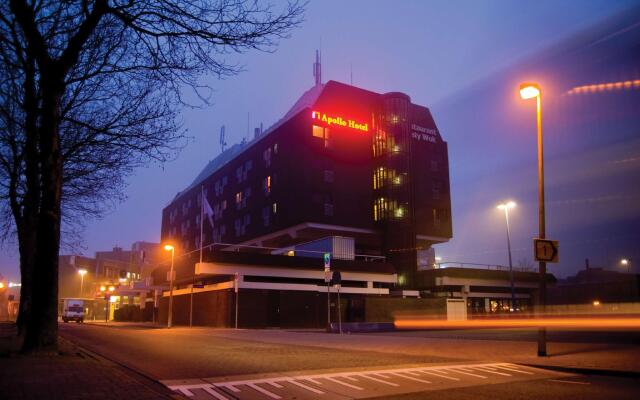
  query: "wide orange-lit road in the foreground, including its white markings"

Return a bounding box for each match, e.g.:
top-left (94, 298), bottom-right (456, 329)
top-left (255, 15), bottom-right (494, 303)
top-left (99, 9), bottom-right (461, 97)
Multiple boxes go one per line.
top-left (60, 324), bottom-right (640, 400)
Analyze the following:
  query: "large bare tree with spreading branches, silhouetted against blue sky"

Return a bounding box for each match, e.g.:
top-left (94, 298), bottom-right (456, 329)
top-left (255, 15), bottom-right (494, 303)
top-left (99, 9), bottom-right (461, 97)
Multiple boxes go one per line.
top-left (0, 0), bottom-right (303, 353)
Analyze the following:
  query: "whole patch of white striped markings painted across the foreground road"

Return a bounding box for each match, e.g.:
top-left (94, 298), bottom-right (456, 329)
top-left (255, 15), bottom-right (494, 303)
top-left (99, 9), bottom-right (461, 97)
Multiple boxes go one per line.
top-left (165, 363), bottom-right (556, 400)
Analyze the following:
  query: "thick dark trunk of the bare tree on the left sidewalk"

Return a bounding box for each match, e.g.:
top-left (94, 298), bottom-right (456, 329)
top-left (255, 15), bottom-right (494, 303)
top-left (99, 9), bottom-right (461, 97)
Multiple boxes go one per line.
top-left (22, 72), bottom-right (64, 354)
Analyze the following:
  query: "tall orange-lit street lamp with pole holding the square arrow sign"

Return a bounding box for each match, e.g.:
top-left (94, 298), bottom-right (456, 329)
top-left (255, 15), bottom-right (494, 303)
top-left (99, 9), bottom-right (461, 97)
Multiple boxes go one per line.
top-left (520, 83), bottom-right (547, 357)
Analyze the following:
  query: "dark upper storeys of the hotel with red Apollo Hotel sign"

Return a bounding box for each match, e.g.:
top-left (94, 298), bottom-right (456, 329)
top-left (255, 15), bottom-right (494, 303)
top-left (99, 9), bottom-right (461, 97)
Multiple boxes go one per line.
top-left (161, 81), bottom-right (452, 287)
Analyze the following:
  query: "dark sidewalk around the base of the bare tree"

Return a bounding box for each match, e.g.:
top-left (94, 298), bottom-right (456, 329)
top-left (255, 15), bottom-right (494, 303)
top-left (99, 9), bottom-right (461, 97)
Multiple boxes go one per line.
top-left (0, 323), bottom-right (182, 400)
